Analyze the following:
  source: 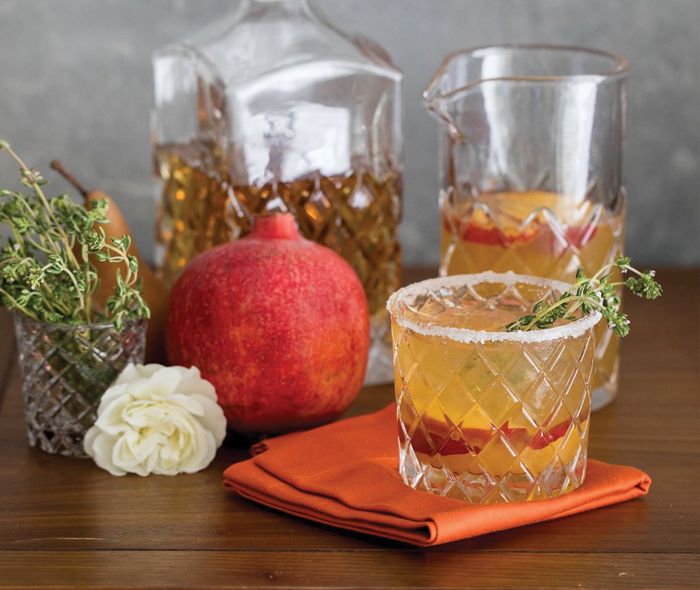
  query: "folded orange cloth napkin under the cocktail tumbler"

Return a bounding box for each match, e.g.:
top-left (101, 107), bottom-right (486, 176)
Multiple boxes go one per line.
top-left (224, 404), bottom-right (651, 546)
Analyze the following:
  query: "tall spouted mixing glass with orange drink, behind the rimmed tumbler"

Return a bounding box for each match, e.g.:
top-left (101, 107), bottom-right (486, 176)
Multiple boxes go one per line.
top-left (424, 45), bottom-right (627, 409)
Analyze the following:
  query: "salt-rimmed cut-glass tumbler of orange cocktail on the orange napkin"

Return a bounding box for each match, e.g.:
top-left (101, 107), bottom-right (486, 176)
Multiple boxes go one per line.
top-left (387, 272), bottom-right (600, 504)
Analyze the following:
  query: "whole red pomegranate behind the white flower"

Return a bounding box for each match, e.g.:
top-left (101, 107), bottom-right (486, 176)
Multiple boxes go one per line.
top-left (166, 213), bottom-right (370, 433)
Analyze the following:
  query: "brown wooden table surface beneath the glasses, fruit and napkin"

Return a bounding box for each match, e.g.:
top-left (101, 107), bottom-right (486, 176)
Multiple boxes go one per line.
top-left (0, 270), bottom-right (700, 588)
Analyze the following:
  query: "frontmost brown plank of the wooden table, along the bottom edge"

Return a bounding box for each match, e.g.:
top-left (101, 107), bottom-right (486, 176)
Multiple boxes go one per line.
top-left (0, 550), bottom-right (700, 590)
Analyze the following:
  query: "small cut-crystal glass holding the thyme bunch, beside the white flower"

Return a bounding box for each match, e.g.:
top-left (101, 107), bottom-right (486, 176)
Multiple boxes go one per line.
top-left (14, 313), bottom-right (147, 457)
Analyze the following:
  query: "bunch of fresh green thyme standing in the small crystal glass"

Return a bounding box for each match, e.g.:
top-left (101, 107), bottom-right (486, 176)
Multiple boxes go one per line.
top-left (0, 140), bottom-right (149, 330)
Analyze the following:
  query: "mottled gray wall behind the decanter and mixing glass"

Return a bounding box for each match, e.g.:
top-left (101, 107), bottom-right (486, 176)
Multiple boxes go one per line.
top-left (0, 0), bottom-right (700, 265)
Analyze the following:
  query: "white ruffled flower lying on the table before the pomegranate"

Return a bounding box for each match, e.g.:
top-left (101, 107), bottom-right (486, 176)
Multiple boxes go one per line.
top-left (83, 364), bottom-right (226, 475)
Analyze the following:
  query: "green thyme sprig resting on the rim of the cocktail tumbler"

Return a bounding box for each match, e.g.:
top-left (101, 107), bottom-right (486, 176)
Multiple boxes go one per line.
top-left (506, 256), bottom-right (662, 336)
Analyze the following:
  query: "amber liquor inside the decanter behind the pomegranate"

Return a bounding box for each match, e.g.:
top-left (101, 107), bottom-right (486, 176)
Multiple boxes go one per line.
top-left (155, 142), bottom-right (401, 323)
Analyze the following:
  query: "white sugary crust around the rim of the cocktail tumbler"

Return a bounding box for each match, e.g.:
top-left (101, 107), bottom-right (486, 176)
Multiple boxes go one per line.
top-left (386, 271), bottom-right (601, 343)
